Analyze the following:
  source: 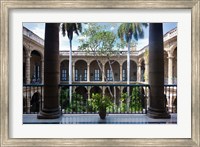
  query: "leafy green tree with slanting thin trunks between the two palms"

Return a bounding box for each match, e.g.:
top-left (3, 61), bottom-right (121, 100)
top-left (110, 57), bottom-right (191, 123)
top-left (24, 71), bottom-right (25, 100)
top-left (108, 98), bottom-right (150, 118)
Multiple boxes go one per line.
top-left (79, 23), bottom-right (123, 108)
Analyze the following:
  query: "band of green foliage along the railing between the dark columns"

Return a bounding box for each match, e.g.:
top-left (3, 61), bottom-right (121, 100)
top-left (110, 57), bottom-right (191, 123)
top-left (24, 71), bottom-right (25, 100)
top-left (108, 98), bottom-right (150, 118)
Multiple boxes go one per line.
top-left (60, 87), bottom-right (144, 113)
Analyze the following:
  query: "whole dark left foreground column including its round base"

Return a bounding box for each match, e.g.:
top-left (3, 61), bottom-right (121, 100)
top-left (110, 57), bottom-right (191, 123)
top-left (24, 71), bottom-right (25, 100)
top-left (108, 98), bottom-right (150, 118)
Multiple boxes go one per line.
top-left (37, 23), bottom-right (61, 119)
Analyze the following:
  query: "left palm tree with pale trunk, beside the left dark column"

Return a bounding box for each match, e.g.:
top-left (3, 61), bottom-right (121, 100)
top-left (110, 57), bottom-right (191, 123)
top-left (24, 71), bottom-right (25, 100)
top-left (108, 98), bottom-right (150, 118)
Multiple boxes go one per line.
top-left (61, 23), bottom-right (82, 103)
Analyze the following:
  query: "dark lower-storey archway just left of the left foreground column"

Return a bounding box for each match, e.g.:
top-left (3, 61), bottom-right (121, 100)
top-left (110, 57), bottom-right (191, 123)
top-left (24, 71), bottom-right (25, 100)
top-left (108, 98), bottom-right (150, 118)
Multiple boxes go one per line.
top-left (30, 92), bottom-right (41, 112)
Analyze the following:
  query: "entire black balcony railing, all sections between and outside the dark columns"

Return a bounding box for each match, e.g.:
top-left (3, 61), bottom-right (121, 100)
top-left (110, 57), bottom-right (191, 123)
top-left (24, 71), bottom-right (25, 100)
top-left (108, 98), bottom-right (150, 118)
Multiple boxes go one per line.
top-left (23, 84), bottom-right (177, 114)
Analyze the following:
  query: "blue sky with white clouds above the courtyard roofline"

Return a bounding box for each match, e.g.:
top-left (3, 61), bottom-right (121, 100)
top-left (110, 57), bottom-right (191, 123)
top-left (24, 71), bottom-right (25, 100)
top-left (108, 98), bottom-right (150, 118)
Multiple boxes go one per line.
top-left (23, 23), bottom-right (177, 50)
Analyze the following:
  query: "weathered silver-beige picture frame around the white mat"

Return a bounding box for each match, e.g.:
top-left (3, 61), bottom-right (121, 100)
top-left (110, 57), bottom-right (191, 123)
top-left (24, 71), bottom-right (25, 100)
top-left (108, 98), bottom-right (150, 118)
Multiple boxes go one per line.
top-left (0, 0), bottom-right (200, 146)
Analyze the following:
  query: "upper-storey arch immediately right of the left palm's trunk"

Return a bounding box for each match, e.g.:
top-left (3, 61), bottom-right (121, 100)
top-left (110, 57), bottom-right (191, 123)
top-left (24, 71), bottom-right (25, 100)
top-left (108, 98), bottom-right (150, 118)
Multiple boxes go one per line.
top-left (75, 60), bottom-right (87, 81)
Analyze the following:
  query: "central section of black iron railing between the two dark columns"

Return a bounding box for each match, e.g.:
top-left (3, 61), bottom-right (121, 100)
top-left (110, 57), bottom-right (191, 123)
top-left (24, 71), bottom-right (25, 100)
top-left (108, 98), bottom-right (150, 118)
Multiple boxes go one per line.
top-left (60, 84), bottom-right (149, 114)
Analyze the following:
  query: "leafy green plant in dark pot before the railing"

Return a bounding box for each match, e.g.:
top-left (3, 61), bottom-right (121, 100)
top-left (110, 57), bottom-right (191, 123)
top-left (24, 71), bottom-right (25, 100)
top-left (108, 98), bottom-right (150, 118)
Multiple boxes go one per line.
top-left (89, 93), bottom-right (113, 119)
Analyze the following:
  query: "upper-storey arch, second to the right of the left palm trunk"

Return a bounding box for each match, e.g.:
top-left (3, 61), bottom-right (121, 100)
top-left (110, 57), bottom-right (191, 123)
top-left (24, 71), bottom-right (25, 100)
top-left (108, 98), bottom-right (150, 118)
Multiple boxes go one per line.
top-left (90, 60), bottom-right (103, 81)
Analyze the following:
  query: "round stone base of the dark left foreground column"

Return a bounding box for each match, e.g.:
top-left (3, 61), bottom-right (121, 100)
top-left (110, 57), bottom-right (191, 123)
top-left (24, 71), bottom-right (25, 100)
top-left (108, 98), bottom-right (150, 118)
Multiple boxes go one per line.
top-left (37, 109), bottom-right (61, 119)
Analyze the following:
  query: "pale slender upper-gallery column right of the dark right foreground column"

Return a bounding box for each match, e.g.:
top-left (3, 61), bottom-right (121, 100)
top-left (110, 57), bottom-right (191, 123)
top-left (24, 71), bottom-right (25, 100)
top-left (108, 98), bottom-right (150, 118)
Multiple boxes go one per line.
top-left (167, 54), bottom-right (174, 84)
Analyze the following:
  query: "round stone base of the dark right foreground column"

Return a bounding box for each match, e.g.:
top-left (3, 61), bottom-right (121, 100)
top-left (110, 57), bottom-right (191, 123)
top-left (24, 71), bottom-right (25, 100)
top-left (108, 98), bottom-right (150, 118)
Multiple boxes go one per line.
top-left (147, 108), bottom-right (171, 119)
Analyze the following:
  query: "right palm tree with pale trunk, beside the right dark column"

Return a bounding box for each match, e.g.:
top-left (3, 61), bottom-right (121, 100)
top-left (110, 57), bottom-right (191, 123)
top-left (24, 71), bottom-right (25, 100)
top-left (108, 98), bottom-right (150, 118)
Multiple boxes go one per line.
top-left (118, 23), bottom-right (147, 111)
